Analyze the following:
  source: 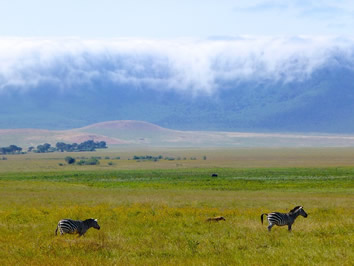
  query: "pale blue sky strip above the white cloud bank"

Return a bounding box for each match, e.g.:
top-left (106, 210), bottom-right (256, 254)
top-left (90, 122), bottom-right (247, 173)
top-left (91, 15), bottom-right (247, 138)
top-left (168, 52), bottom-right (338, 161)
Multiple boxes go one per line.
top-left (0, 0), bottom-right (354, 39)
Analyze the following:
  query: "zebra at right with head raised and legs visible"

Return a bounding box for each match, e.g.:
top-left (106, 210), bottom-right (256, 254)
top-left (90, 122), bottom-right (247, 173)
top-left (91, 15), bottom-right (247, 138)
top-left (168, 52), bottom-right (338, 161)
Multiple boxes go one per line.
top-left (261, 206), bottom-right (307, 232)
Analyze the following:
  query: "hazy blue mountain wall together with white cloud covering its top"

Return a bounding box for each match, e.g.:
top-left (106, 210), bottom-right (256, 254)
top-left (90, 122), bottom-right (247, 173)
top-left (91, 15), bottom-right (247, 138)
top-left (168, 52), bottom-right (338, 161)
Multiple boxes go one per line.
top-left (0, 37), bottom-right (354, 133)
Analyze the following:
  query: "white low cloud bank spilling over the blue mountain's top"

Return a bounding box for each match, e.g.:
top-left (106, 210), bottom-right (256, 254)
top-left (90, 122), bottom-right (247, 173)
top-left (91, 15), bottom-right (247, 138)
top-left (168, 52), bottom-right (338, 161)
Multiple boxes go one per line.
top-left (0, 37), bottom-right (354, 94)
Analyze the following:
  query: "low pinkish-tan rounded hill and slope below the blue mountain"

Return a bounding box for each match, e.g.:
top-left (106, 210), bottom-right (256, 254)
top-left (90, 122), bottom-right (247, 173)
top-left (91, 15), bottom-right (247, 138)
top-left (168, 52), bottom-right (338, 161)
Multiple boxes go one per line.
top-left (0, 120), bottom-right (354, 148)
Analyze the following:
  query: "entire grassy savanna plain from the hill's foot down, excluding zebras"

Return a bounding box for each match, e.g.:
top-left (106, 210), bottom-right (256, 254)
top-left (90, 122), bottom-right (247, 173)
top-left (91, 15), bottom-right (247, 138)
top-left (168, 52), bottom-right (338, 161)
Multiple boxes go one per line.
top-left (0, 148), bottom-right (354, 265)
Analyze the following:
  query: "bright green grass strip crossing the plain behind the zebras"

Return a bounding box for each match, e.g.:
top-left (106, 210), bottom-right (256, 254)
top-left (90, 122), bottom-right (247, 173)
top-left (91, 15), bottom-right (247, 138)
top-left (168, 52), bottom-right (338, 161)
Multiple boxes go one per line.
top-left (0, 167), bottom-right (354, 192)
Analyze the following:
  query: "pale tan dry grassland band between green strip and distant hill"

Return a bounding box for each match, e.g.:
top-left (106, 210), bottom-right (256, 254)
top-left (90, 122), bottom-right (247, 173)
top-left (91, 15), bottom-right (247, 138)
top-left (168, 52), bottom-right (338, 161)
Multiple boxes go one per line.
top-left (0, 147), bottom-right (354, 173)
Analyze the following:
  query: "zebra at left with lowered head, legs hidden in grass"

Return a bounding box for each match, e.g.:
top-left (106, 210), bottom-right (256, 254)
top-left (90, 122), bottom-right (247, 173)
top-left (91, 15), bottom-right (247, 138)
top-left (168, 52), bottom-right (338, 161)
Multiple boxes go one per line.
top-left (55, 219), bottom-right (100, 236)
